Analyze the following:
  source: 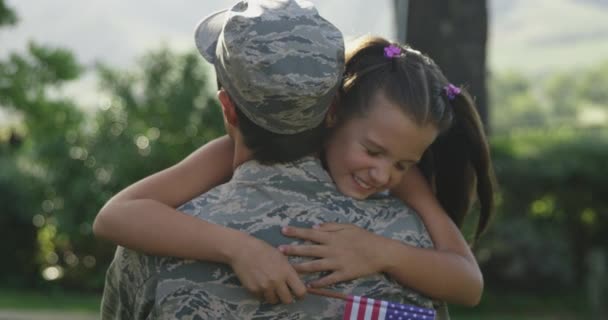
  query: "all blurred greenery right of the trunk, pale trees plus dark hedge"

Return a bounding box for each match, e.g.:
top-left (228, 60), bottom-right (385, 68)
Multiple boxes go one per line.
top-left (484, 61), bottom-right (608, 294)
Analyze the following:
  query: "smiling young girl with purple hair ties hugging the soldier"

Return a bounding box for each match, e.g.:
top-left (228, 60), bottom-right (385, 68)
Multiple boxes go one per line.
top-left (94, 38), bottom-right (493, 305)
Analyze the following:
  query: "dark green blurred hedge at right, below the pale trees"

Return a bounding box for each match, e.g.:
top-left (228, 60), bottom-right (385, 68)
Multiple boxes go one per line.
top-left (477, 127), bottom-right (608, 290)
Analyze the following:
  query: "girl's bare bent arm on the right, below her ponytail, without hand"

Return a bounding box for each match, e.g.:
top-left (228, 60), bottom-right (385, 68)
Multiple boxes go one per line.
top-left (386, 167), bottom-right (483, 306)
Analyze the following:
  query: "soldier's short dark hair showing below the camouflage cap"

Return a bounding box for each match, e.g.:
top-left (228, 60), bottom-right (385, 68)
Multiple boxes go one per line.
top-left (217, 80), bottom-right (327, 164)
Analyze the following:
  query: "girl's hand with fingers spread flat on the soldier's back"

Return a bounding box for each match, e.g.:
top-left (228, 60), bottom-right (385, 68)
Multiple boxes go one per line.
top-left (279, 223), bottom-right (384, 288)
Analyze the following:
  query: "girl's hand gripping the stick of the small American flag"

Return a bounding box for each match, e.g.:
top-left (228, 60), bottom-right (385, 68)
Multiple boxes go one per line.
top-left (229, 238), bottom-right (306, 304)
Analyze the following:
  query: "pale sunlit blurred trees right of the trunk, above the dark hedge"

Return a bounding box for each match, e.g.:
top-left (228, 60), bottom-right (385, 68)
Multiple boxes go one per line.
top-left (489, 61), bottom-right (608, 134)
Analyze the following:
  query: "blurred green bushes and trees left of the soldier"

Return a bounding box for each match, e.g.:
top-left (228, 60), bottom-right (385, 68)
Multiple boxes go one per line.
top-left (0, 40), bottom-right (223, 289)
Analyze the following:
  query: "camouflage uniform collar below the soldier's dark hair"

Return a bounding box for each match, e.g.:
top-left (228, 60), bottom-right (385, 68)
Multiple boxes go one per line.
top-left (232, 156), bottom-right (332, 183)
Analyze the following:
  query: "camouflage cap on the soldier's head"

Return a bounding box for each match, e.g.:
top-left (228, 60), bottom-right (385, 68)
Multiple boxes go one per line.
top-left (195, 0), bottom-right (344, 134)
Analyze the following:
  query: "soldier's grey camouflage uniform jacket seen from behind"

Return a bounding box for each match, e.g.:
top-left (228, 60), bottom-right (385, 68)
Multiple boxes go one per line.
top-left (102, 157), bottom-right (448, 320)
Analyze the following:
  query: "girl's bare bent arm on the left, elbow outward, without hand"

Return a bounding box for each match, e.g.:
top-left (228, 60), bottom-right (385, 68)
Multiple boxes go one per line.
top-left (93, 136), bottom-right (234, 259)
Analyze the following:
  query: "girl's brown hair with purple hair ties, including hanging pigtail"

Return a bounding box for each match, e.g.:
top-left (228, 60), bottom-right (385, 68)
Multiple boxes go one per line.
top-left (336, 37), bottom-right (495, 239)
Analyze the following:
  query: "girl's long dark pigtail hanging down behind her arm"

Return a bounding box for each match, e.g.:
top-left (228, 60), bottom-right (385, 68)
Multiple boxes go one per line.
top-left (422, 91), bottom-right (495, 240)
